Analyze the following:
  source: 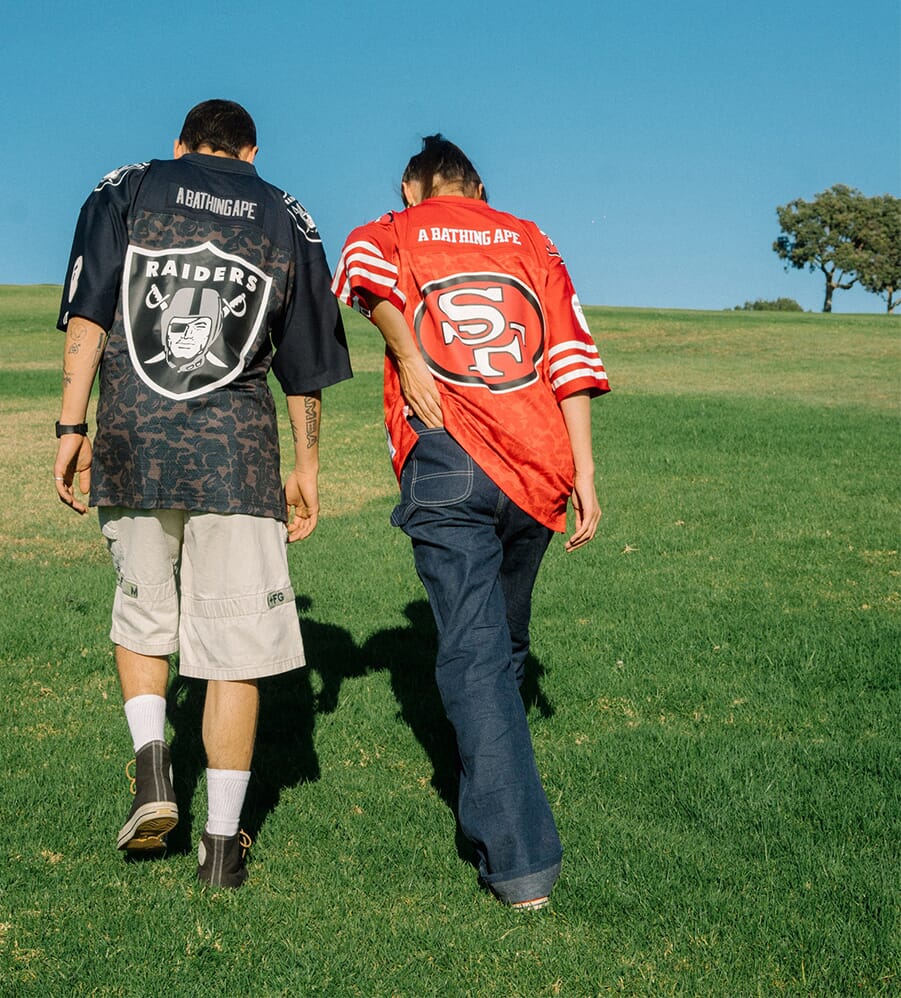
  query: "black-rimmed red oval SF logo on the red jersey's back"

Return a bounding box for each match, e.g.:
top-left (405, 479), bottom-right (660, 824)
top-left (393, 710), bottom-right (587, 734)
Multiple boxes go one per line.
top-left (413, 274), bottom-right (544, 393)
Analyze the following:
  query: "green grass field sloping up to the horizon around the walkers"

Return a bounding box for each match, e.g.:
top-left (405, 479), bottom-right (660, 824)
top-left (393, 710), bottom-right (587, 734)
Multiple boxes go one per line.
top-left (0, 287), bottom-right (901, 996)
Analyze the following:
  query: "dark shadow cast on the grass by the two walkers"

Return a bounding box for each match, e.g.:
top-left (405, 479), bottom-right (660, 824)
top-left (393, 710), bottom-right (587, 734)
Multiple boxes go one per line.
top-left (167, 596), bottom-right (553, 865)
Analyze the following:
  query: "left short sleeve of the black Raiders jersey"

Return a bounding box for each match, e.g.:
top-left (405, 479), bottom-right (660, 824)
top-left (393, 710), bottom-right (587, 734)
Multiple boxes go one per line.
top-left (57, 163), bottom-right (149, 330)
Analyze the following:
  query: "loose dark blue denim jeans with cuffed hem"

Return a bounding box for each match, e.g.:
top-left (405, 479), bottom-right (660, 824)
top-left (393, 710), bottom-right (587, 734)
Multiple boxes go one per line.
top-left (391, 422), bottom-right (562, 904)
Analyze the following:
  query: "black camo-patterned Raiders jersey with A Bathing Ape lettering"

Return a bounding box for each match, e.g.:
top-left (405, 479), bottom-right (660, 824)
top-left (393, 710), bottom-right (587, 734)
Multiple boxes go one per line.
top-left (58, 153), bottom-right (351, 519)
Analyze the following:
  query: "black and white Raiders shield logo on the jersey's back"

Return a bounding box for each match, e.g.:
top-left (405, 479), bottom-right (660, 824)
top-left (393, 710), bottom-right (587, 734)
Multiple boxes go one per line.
top-left (122, 243), bottom-right (272, 400)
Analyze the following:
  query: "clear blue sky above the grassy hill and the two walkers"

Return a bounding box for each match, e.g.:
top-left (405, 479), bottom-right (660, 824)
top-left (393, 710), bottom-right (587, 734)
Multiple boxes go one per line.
top-left (0, 0), bottom-right (901, 312)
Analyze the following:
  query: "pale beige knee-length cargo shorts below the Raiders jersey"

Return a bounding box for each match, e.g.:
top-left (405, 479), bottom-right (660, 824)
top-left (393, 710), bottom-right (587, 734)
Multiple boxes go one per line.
top-left (99, 507), bottom-right (306, 680)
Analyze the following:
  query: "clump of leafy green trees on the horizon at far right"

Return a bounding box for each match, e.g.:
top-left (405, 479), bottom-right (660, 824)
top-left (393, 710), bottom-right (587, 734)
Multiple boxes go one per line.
top-left (773, 184), bottom-right (901, 312)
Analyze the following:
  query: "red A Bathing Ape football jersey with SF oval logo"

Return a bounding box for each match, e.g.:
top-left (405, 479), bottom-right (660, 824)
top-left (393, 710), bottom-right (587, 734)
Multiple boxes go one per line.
top-left (332, 197), bottom-right (610, 530)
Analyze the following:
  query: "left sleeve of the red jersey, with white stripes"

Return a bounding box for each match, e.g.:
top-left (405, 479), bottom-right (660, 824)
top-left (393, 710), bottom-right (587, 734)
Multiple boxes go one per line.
top-left (332, 213), bottom-right (406, 315)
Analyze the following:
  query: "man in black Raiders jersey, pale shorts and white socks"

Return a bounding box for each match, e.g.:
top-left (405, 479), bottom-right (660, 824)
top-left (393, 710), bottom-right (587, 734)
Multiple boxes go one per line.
top-left (53, 100), bottom-right (351, 887)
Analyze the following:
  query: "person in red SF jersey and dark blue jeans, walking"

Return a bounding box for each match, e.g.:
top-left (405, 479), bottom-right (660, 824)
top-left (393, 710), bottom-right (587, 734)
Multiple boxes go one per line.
top-left (332, 135), bottom-right (609, 908)
